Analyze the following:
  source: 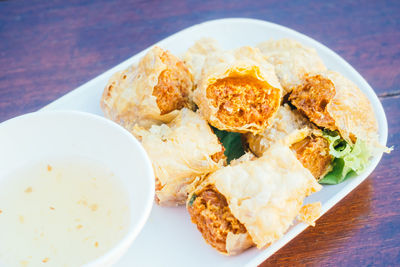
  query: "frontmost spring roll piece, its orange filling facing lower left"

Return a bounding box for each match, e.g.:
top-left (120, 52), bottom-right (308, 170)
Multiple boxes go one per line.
top-left (187, 142), bottom-right (321, 255)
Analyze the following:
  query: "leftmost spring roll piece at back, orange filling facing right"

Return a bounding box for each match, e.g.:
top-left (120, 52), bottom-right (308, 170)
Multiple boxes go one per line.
top-left (100, 46), bottom-right (193, 128)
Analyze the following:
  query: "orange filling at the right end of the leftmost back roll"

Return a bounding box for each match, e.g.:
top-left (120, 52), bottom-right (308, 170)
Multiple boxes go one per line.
top-left (153, 52), bottom-right (192, 115)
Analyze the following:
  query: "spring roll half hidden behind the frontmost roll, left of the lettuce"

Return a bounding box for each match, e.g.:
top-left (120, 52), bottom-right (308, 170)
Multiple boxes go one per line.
top-left (245, 104), bottom-right (333, 179)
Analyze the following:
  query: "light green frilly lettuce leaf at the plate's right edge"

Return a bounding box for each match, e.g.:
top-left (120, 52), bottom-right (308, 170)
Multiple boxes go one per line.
top-left (319, 131), bottom-right (371, 184)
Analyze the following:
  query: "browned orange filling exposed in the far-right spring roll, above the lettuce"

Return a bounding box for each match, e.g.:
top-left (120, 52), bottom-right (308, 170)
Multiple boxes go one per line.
top-left (289, 75), bottom-right (337, 131)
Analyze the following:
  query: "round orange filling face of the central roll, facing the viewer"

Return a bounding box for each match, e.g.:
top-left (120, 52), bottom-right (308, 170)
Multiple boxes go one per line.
top-left (207, 75), bottom-right (280, 131)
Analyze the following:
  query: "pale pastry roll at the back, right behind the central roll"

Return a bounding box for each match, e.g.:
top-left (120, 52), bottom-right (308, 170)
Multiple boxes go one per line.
top-left (257, 39), bottom-right (326, 94)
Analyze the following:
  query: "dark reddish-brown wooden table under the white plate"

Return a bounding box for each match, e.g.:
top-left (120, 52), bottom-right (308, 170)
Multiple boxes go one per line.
top-left (0, 0), bottom-right (400, 267)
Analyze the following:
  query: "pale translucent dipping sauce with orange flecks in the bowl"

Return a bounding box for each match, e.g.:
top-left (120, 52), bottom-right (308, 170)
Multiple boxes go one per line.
top-left (0, 158), bottom-right (130, 267)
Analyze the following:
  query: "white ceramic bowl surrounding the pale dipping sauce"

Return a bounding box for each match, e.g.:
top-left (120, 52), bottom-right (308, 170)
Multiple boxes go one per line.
top-left (0, 111), bottom-right (154, 266)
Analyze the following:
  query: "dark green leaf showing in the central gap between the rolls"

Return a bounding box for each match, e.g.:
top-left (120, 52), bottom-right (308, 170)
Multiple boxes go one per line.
top-left (212, 127), bottom-right (245, 164)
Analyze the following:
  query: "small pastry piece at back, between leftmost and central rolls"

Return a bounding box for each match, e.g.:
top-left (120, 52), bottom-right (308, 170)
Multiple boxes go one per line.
top-left (182, 38), bottom-right (222, 86)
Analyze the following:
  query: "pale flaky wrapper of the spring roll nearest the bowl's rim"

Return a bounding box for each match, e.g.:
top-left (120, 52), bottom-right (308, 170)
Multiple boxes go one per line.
top-left (131, 108), bottom-right (225, 205)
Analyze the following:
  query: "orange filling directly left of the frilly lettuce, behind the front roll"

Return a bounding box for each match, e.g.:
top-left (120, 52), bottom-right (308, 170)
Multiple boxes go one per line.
top-left (291, 136), bottom-right (332, 179)
